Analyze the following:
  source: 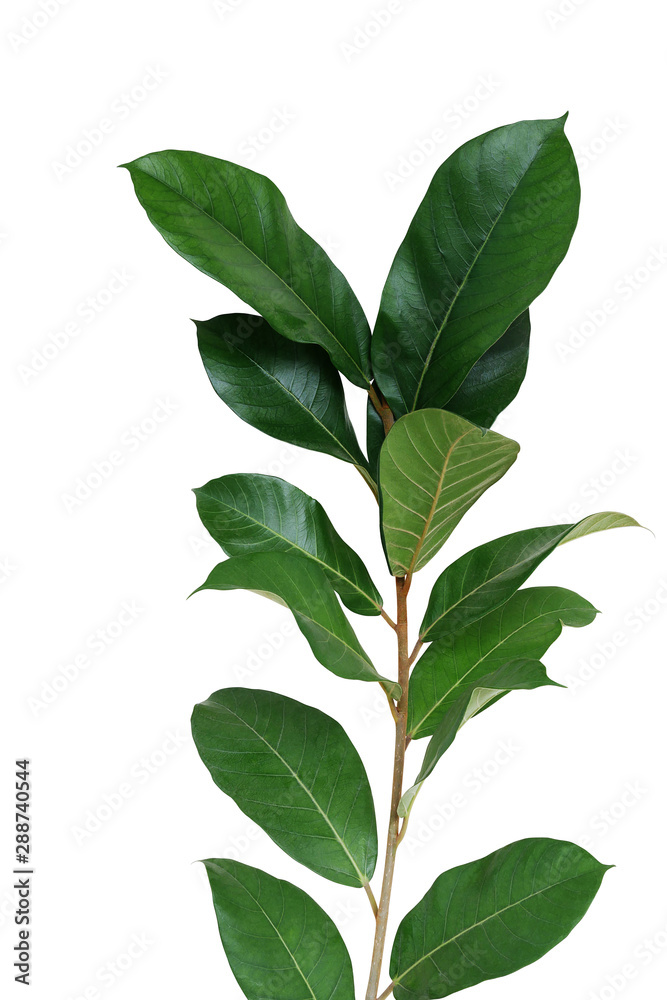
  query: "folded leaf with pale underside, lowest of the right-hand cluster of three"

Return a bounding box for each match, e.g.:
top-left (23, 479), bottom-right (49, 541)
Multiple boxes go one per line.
top-left (398, 657), bottom-right (563, 816)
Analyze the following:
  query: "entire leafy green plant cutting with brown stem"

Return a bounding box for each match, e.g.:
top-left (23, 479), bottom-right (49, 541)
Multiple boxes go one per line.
top-left (126, 118), bottom-right (637, 1000)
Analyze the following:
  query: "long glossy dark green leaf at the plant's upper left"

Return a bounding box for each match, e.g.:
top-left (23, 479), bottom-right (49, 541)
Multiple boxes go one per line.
top-left (123, 149), bottom-right (370, 388)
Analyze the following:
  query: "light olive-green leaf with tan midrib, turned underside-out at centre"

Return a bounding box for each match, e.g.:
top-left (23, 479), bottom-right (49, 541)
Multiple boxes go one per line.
top-left (380, 410), bottom-right (519, 576)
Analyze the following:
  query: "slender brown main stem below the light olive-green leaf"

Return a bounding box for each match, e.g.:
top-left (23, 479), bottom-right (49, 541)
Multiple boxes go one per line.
top-left (366, 577), bottom-right (410, 1000)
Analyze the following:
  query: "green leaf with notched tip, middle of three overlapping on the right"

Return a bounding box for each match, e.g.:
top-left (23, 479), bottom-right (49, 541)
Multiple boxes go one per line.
top-left (408, 587), bottom-right (597, 739)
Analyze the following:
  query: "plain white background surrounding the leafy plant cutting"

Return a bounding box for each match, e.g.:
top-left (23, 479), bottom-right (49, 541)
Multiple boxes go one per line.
top-left (0, 0), bottom-right (667, 1000)
